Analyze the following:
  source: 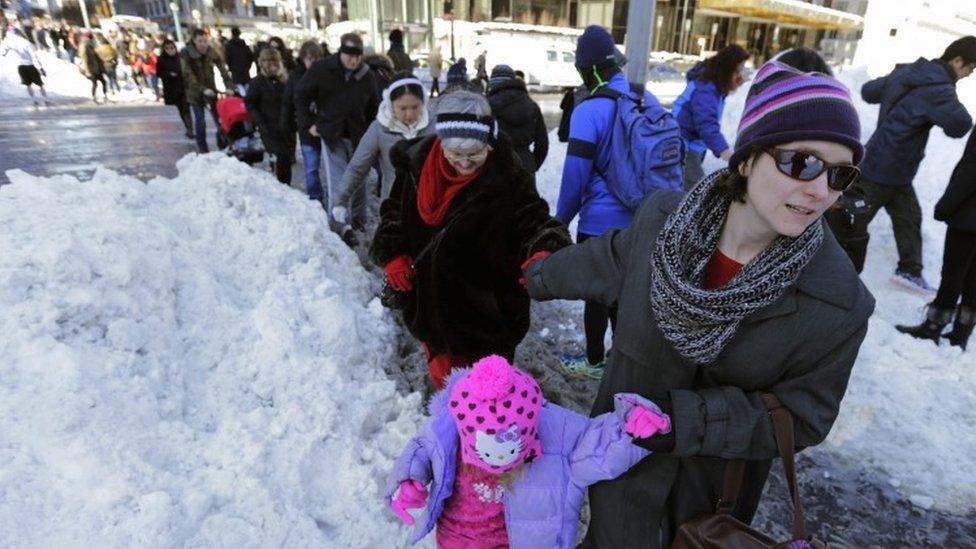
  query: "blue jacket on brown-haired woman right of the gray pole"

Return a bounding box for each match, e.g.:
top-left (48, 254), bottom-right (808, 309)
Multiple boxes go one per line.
top-left (671, 63), bottom-right (729, 156)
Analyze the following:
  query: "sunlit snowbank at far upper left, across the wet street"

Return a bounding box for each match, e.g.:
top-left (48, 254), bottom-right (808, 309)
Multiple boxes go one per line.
top-left (0, 34), bottom-right (162, 106)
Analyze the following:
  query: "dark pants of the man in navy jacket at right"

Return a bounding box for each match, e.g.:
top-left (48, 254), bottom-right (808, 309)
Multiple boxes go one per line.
top-left (855, 179), bottom-right (922, 275)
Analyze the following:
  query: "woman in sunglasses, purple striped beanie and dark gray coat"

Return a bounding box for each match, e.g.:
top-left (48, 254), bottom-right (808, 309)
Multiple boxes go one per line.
top-left (525, 62), bottom-right (874, 547)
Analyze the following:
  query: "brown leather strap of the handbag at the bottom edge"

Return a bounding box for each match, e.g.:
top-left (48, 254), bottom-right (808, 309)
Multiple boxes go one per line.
top-left (716, 393), bottom-right (807, 539)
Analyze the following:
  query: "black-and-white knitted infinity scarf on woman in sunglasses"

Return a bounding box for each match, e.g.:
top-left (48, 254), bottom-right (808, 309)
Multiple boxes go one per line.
top-left (651, 169), bottom-right (824, 365)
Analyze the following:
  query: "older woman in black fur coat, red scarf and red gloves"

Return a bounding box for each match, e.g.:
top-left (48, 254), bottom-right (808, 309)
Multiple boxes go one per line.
top-left (371, 91), bottom-right (570, 389)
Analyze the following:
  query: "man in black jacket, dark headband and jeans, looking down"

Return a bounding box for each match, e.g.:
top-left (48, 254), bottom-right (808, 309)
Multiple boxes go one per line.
top-left (295, 33), bottom-right (380, 230)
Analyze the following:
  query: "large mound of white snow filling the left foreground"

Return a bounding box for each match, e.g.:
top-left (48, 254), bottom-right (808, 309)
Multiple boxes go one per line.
top-left (0, 153), bottom-right (422, 547)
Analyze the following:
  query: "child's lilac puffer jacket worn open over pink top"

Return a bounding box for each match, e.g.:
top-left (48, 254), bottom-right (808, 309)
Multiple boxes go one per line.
top-left (386, 369), bottom-right (659, 549)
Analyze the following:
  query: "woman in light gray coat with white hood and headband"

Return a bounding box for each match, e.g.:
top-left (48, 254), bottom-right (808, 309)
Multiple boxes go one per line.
top-left (332, 71), bottom-right (432, 230)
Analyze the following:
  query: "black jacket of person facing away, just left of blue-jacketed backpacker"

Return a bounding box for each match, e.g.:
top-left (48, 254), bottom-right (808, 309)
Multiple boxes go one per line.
top-left (488, 78), bottom-right (549, 173)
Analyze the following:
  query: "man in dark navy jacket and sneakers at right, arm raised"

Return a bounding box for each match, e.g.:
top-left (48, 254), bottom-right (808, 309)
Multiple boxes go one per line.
top-left (858, 36), bottom-right (976, 293)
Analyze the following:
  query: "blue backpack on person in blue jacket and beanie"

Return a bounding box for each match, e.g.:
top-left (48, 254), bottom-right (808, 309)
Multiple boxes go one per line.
top-left (587, 88), bottom-right (684, 210)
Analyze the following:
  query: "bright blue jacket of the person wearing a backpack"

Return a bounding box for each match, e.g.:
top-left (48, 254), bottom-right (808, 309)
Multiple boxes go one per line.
top-left (556, 73), bottom-right (650, 236)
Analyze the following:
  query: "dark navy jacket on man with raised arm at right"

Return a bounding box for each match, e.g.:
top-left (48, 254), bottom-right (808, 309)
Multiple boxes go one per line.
top-left (861, 57), bottom-right (973, 185)
